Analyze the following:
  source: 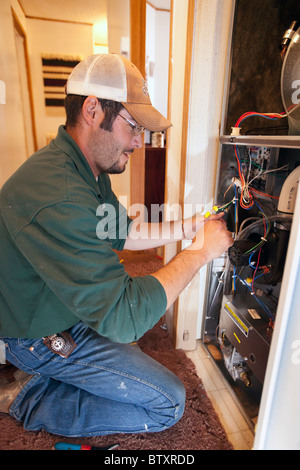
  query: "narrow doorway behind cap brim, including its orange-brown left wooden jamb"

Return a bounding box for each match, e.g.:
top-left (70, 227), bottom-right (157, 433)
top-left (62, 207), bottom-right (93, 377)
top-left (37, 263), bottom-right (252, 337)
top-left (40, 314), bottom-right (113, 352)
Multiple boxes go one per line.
top-left (130, 0), bottom-right (171, 221)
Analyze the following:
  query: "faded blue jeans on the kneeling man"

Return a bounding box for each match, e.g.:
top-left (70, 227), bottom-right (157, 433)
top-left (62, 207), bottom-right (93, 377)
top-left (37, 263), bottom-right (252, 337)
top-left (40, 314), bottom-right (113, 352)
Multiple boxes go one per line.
top-left (0, 322), bottom-right (185, 437)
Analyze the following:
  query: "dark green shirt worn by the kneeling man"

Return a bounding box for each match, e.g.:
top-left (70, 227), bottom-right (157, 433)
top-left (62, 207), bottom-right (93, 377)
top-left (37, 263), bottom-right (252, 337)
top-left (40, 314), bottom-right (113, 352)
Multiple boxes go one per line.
top-left (0, 126), bottom-right (167, 342)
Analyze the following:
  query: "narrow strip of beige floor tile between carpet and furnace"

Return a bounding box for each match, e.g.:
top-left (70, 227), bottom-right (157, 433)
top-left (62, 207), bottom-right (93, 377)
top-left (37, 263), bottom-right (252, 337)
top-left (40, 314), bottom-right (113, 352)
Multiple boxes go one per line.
top-left (186, 341), bottom-right (254, 450)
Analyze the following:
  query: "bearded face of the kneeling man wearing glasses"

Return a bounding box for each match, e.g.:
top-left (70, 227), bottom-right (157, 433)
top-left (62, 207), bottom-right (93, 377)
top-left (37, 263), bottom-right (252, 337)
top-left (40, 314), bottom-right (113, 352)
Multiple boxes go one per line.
top-left (88, 109), bottom-right (143, 174)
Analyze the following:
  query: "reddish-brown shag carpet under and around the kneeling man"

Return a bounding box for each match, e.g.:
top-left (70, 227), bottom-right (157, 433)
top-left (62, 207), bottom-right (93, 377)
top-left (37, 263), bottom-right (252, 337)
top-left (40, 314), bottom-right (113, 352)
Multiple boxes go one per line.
top-left (0, 252), bottom-right (232, 454)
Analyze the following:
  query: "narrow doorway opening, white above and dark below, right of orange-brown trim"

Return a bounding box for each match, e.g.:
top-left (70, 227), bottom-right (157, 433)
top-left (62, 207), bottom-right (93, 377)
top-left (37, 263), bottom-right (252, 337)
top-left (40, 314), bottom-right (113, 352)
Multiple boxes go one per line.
top-left (144, 0), bottom-right (170, 222)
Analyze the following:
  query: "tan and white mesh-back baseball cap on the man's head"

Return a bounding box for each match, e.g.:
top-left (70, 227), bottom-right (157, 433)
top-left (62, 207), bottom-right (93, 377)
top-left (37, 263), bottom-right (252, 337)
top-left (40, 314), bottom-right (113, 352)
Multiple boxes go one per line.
top-left (66, 54), bottom-right (172, 131)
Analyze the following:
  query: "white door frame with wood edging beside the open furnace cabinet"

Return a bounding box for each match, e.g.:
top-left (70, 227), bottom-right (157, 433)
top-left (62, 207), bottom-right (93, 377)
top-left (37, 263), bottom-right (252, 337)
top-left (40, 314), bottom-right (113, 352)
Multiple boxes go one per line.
top-left (165, 0), bottom-right (234, 350)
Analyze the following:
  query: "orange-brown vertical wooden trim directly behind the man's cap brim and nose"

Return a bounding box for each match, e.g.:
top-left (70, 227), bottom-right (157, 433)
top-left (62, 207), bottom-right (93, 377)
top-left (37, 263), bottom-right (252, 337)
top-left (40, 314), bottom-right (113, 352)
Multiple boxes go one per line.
top-left (130, 0), bottom-right (146, 209)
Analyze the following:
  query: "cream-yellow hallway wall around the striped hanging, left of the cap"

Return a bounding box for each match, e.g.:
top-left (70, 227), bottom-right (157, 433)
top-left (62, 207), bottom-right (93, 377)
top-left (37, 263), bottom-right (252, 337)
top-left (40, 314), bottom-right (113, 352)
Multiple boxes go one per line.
top-left (0, 0), bottom-right (93, 186)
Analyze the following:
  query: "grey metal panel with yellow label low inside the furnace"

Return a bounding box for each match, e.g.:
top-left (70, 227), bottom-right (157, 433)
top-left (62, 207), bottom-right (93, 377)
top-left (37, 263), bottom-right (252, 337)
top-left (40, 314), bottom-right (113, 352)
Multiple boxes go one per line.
top-left (219, 295), bottom-right (272, 383)
